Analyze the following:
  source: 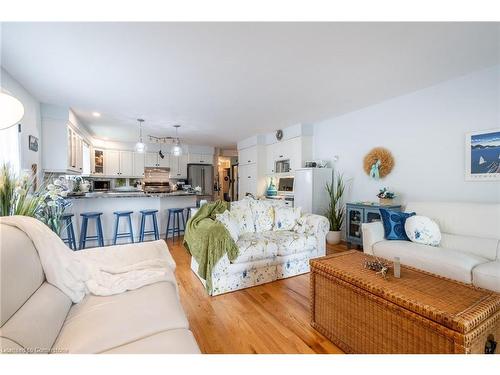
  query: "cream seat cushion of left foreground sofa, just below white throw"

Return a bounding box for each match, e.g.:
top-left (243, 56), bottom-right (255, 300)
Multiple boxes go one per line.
top-left (54, 282), bottom-right (188, 353)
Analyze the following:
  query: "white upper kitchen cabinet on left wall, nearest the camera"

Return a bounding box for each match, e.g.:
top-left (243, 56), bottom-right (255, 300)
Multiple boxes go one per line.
top-left (41, 104), bottom-right (84, 174)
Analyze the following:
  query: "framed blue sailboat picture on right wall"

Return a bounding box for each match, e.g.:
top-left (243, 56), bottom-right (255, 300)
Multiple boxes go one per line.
top-left (465, 128), bottom-right (500, 181)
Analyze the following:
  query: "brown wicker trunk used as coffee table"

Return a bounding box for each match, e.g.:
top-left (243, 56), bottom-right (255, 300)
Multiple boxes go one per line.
top-left (310, 250), bottom-right (500, 353)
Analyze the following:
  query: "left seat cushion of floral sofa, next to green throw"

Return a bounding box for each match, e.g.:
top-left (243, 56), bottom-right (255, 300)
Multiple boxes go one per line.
top-left (231, 233), bottom-right (278, 263)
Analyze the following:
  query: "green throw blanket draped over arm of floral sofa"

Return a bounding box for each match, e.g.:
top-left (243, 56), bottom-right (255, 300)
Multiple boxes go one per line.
top-left (184, 200), bottom-right (238, 293)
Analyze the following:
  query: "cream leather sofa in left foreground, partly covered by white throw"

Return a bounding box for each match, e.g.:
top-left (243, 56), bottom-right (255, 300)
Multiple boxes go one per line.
top-left (0, 225), bottom-right (199, 353)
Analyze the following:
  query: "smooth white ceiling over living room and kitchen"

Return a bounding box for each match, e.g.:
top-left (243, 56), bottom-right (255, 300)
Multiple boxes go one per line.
top-left (1, 23), bottom-right (500, 146)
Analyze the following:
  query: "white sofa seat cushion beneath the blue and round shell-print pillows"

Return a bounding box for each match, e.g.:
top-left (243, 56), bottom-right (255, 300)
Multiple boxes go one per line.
top-left (373, 241), bottom-right (488, 284)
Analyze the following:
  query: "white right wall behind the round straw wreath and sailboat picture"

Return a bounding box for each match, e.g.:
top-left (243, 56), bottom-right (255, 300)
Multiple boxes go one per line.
top-left (313, 66), bottom-right (500, 202)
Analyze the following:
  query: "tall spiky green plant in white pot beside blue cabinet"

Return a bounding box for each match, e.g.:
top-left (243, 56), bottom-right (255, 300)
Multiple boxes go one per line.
top-left (326, 173), bottom-right (345, 245)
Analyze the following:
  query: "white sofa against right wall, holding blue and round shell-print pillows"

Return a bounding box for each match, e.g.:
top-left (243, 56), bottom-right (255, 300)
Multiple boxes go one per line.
top-left (362, 202), bottom-right (500, 292)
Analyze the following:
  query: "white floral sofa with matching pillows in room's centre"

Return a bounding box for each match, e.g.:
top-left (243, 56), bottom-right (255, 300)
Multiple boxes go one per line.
top-left (191, 198), bottom-right (329, 295)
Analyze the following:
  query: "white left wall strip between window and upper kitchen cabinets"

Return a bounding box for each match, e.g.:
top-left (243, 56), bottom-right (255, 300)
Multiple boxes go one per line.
top-left (1, 68), bottom-right (42, 176)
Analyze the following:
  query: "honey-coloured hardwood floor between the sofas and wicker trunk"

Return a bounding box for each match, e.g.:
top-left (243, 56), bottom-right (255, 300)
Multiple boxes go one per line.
top-left (167, 239), bottom-right (346, 354)
